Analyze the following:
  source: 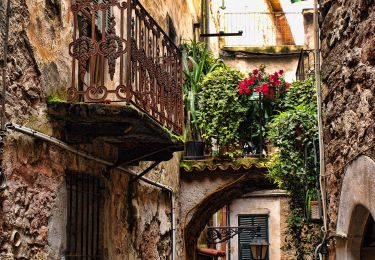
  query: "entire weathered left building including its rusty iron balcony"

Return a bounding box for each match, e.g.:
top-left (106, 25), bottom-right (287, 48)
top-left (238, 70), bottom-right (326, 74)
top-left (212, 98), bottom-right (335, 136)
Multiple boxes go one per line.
top-left (0, 0), bottom-right (200, 260)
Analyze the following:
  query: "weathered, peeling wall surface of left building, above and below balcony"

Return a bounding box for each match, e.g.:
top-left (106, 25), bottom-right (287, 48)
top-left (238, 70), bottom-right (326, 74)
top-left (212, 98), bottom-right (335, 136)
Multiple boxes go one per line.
top-left (0, 0), bottom-right (199, 260)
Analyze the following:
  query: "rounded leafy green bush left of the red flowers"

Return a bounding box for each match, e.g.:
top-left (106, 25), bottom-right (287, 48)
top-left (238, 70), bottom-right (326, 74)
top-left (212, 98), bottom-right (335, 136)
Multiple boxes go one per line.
top-left (198, 67), bottom-right (248, 148)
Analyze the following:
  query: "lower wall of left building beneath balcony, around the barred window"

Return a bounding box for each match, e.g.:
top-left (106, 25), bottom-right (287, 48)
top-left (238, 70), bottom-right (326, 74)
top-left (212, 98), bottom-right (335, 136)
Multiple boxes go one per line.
top-left (0, 133), bottom-right (179, 260)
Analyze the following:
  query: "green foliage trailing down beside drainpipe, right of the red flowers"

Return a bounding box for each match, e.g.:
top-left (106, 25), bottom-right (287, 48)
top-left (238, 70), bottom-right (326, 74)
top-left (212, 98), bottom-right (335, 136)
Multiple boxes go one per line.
top-left (267, 78), bottom-right (319, 259)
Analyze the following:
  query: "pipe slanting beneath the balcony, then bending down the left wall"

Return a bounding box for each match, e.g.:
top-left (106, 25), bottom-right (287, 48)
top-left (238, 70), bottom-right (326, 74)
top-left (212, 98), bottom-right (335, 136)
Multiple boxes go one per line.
top-left (6, 123), bottom-right (176, 260)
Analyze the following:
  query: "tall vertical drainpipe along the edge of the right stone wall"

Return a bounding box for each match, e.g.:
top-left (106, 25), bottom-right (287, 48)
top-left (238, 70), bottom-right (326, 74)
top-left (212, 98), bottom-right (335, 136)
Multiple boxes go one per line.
top-left (314, 0), bottom-right (327, 259)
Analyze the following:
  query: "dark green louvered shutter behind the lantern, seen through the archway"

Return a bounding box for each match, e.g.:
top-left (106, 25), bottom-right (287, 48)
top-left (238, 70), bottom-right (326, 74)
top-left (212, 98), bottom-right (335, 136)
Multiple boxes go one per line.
top-left (238, 215), bottom-right (269, 260)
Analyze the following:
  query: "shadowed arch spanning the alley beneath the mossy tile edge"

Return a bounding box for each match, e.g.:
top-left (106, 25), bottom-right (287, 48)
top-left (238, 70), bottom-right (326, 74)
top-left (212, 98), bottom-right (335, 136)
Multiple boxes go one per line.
top-left (180, 169), bottom-right (274, 260)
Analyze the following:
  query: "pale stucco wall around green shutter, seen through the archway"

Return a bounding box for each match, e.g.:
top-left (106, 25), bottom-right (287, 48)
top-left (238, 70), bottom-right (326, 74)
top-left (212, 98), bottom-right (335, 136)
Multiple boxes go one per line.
top-left (229, 191), bottom-right (288, 260)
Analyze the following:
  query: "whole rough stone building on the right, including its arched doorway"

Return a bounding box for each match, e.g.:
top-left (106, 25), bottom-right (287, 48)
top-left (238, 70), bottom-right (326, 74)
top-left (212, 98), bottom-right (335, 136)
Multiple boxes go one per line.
top-left (319, 0), bottom-right (375, 260)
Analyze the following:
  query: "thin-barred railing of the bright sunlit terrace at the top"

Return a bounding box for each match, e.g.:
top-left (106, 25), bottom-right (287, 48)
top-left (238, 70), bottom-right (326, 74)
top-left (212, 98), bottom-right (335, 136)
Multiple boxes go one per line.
top-left (224, 12), bottom-right (303, 47)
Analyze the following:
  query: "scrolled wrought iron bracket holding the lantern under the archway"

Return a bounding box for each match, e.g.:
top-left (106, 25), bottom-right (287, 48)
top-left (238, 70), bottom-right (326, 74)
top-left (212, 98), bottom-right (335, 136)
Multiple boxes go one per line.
top-left (207, 226), bottom-right (260, 244)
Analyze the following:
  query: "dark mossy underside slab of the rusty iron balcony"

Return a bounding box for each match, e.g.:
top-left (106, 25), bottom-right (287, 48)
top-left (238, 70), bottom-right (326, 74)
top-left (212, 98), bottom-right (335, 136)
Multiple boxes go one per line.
top-left (48, 102), bottom-right (183, 165)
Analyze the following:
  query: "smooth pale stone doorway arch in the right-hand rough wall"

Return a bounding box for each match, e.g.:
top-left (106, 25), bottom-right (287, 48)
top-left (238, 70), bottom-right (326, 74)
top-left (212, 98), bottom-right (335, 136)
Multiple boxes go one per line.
top-left (336, 156), bottom-right (375, 260)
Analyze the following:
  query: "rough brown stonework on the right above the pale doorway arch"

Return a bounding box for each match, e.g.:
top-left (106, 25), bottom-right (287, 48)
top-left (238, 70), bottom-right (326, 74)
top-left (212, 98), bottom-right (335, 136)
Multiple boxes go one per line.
top-left (320, 0), bottom-right (375, 245)
